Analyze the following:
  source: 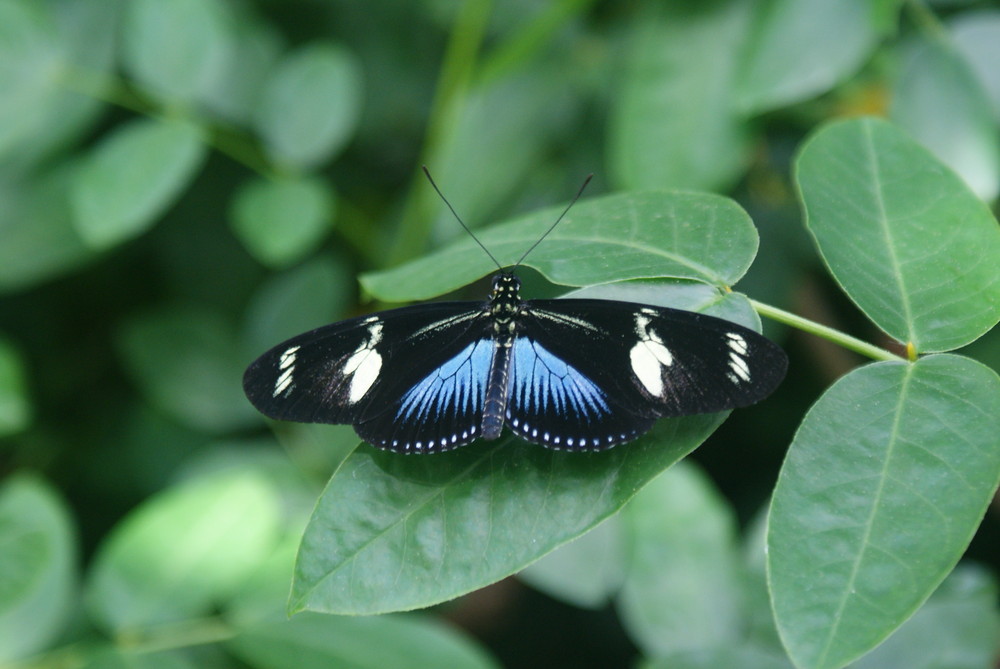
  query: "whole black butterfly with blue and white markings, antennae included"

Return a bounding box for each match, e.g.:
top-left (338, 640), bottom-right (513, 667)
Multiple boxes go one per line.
top-left (243, 169), bottom-right (788, 453)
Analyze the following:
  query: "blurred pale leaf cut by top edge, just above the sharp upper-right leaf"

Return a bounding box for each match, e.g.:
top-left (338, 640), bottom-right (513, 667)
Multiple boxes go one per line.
top-left (736, 0), bottom-right (878, 114)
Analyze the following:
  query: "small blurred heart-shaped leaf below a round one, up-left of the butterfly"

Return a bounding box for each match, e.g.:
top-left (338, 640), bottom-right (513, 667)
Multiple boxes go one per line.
top-left (230, 177), bottom-right (336, 267)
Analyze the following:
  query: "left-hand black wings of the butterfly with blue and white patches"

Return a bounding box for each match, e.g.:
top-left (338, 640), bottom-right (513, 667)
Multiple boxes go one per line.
top-left (243, 302), bottom-right (493, 452)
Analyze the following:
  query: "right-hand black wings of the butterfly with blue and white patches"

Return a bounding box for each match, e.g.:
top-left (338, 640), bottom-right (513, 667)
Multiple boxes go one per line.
top-left (507, 300), bottom-right (788, 450)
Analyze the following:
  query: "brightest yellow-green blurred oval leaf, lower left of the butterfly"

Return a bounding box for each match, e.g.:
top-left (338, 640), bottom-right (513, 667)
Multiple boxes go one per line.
top-left (87, 474), bottom-right (280, 633)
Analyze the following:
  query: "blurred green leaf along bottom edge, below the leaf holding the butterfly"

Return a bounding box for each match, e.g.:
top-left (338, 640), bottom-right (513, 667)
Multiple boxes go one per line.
top-left (226, 613), bottom-right (498, 669)
